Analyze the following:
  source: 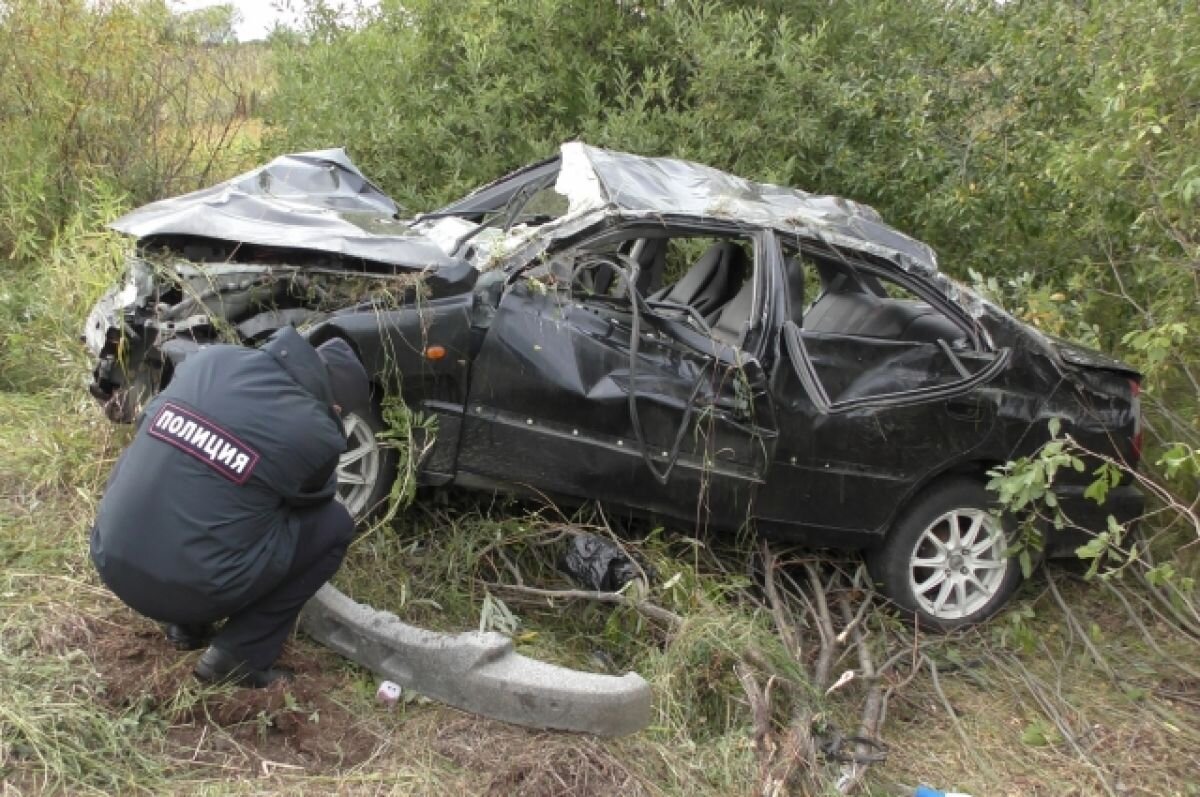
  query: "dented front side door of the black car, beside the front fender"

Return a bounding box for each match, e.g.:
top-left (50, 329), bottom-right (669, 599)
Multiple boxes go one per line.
top-left (458, 222), bottom-right (775, 527)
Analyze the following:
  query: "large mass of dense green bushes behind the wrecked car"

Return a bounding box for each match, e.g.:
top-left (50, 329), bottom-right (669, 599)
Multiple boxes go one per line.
top-left (270, 0), bottom-right (1200, 463)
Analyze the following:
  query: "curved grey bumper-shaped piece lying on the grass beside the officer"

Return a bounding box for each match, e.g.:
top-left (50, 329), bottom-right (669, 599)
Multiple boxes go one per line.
top-left (300, 585), bottom-right (650, 736)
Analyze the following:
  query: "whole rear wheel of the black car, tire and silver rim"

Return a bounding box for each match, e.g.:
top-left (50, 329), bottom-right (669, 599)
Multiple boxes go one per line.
top-left (866, 478), bottom-right (1021, 631)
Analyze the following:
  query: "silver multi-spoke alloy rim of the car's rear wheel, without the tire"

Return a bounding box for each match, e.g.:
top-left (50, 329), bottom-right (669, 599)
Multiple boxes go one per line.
top-left (908, 509), bottom-right (1009, 619)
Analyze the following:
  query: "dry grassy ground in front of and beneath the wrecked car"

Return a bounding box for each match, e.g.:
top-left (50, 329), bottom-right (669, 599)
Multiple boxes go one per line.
top-left (0, 392), bottom-right (1200, 797)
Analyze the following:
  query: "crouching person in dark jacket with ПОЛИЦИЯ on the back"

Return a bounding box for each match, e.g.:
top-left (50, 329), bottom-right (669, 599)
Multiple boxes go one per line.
top-left (91, 326), bottom-right (370, 688)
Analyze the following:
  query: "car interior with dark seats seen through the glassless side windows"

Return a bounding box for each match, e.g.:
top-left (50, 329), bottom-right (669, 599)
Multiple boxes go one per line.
top-left (572, 233), bottom-right (972, 386)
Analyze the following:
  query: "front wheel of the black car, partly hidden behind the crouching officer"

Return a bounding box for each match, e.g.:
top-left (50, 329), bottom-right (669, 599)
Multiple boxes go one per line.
top-left (337, 401), bottom-right (396, 527)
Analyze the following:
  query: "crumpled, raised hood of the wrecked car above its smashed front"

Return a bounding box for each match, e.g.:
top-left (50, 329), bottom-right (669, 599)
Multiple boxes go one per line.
top-left (109, 149), bottom-right (456, 269)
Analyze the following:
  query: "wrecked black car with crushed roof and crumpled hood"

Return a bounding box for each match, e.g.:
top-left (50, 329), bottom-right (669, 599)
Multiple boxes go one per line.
top-left (85, 143), bottom-right (1141, 628)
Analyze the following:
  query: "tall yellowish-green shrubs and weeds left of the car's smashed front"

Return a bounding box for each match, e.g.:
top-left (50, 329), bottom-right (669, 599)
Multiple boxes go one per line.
top-left (0, 0), bottom-right (268, 392)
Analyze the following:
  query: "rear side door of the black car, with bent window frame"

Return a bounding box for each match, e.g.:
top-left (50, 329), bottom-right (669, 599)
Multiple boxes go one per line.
top-left (756, 235), bottom-right (1008, 546)
